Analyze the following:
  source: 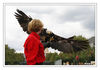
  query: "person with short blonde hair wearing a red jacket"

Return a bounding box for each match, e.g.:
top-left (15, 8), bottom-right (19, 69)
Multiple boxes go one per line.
top-left (24, 19), bottom-right (45, 65)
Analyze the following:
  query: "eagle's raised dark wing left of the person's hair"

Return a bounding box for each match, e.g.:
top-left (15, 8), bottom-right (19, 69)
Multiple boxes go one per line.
top-left (15, 9), bottom-right (32, 34)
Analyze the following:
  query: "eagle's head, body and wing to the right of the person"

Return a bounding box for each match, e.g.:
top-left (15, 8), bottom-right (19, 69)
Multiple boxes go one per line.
top-left (40, 29), bottom-right (89, 53)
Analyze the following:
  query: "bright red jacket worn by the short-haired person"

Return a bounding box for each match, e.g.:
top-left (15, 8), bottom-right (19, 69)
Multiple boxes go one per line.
top-left (24, 32), bottom-right (45, 65)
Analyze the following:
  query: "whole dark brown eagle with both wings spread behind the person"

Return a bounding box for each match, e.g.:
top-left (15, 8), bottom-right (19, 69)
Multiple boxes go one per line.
top-left (15, 9), bottom-right (89, 53)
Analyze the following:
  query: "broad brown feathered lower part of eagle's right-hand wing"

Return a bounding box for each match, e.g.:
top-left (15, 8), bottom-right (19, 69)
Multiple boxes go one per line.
top-left (51, 40), bottom-right (89, 53)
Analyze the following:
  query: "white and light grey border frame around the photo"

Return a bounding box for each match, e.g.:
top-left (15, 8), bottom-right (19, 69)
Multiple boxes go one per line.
top-left (3, 3), bottom-right (97, 70)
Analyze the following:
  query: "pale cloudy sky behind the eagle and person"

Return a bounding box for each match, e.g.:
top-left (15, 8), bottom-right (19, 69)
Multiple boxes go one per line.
top-left (5, 5), bottom-right (95, 53)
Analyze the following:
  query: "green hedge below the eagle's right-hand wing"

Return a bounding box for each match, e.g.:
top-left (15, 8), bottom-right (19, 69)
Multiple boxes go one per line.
top-left (46, 48), bottom-right (95, 64)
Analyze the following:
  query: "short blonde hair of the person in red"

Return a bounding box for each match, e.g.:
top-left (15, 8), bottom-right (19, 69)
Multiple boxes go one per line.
top-left (28, 19), bottom-right (43, 33)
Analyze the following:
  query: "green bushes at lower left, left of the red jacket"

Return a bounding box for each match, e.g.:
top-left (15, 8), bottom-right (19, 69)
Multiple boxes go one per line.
top-left (5, 45), bottom-right (24, 65)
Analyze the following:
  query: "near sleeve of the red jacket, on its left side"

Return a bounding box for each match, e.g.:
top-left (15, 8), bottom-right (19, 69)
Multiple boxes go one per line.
top-left (25, 38), bottom-right (39, 64)
